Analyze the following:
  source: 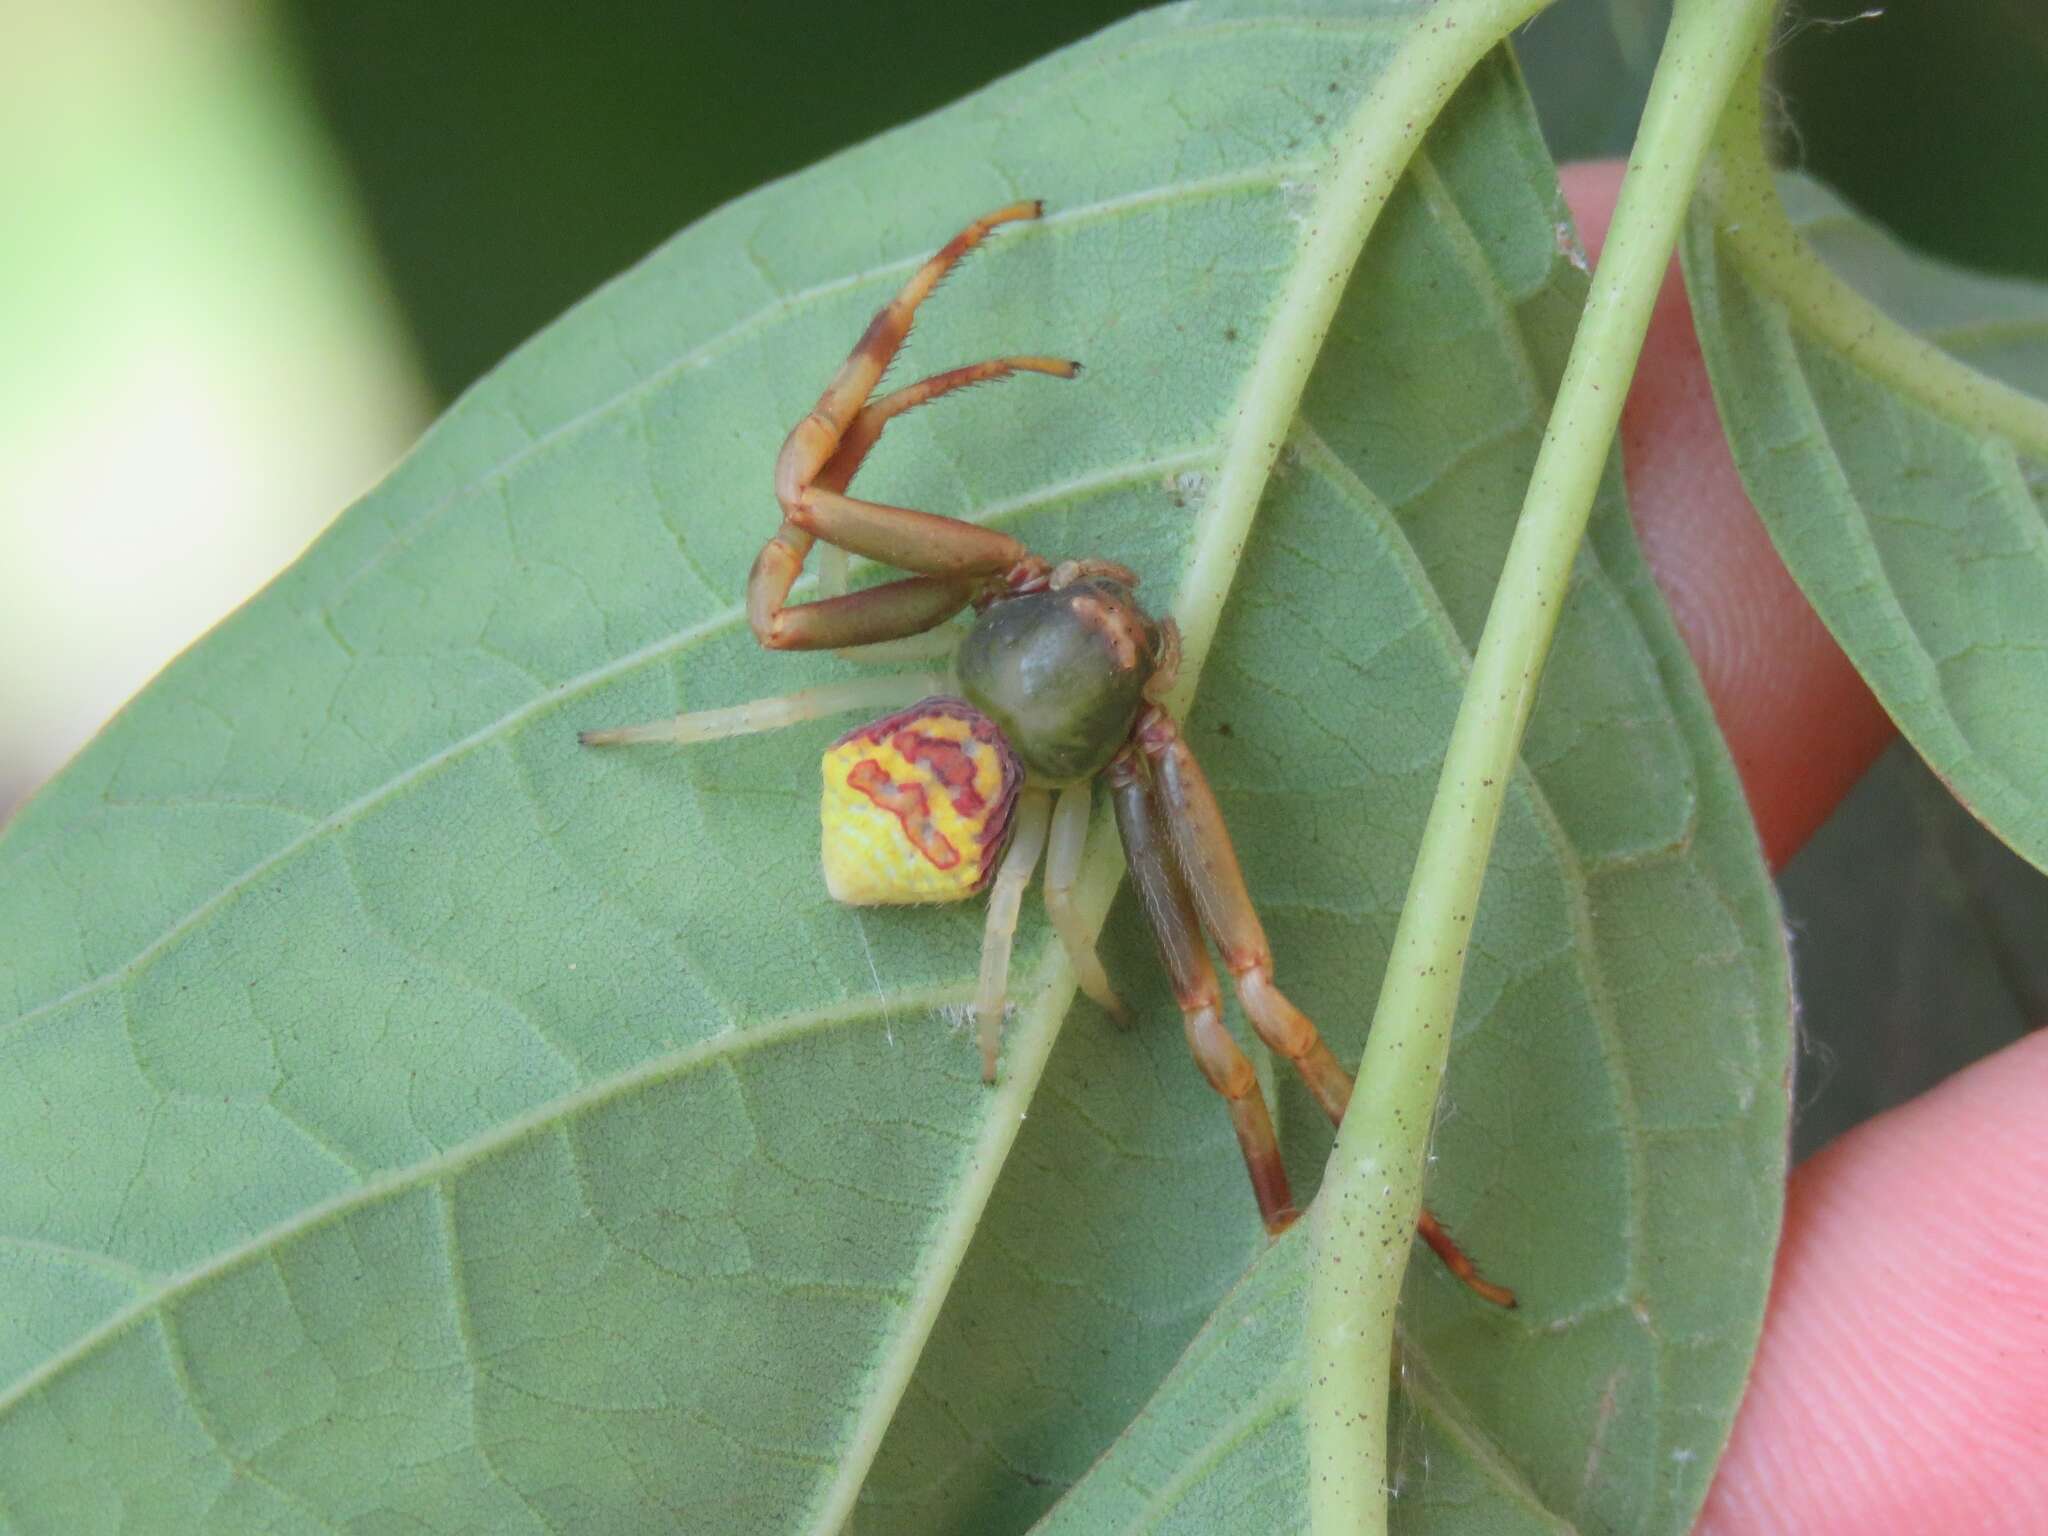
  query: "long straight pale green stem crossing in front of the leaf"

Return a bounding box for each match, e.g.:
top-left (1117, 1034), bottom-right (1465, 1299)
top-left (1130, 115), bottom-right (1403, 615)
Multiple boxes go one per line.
top-left (1307, 0), bottom-right (1769, 1536)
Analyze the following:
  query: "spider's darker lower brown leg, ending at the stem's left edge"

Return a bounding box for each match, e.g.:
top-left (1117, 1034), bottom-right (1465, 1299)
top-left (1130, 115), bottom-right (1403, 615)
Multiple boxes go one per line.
top-left (1110, 748), bottom-right (1298, 1235)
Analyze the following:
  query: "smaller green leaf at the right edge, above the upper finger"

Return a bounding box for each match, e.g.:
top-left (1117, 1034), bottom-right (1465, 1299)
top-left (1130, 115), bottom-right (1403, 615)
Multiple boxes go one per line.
top-left (1683, 96), bottom-right (2048, 868)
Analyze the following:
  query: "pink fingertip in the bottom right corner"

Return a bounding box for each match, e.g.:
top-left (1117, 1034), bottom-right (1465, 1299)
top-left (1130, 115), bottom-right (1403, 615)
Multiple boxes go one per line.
top-left (1696, 1020), bottom-right (2048, 1536)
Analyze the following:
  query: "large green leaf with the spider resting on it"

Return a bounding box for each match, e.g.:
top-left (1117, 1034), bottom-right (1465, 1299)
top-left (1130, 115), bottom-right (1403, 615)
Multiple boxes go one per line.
top-left (0, 4), bottom-right (1788, 1536)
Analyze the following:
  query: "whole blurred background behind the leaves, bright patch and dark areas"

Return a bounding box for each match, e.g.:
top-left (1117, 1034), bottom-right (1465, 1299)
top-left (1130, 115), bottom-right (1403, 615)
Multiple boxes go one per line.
top-left (0, 0), bottom-right (2048, 1151)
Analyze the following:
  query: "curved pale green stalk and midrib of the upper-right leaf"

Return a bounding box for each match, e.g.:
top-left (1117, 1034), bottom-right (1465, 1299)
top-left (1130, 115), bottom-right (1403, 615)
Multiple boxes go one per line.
top-left (1700, 45), bottom-right (2048, 459)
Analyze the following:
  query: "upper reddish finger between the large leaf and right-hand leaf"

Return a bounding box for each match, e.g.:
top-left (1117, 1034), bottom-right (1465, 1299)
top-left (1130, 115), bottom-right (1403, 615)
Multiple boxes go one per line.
top-left (1561, 162), bottom-right (1896, 868)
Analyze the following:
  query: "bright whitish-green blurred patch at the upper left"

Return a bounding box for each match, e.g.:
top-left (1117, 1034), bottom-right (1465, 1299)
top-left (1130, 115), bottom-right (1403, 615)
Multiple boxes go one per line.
top-left (0, 0), bottom-right (430, 815)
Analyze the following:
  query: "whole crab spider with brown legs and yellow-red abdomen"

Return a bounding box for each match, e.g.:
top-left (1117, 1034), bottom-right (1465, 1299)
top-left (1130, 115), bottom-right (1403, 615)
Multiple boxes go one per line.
top-left (584, 203), bottom-right (1513, 1307)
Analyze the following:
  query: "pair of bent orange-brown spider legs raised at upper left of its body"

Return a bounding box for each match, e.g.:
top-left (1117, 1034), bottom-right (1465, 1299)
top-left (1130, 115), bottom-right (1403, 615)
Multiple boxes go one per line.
top-left (748, 203), bottom-right (1075, 649)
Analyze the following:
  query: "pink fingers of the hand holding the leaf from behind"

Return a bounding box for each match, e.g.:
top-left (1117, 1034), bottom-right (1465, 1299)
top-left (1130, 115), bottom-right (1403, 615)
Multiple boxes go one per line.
top-left (1563, 164), bottom-right (2048, 1536)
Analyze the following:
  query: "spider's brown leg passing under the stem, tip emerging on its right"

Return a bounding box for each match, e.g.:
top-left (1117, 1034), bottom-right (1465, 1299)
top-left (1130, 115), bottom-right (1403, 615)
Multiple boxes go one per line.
top-left (1137, 705), bottom-right (1516, 1307)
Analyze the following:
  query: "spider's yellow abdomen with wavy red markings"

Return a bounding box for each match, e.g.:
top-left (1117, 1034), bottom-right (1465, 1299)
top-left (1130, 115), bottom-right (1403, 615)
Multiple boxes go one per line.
top-left (821, 698), bottom-right (1024, 907)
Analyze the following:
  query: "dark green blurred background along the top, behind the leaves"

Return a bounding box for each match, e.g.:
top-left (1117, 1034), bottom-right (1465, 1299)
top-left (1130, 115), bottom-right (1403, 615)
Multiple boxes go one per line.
top-left (281, 0), bottom-right (2048, 399)
